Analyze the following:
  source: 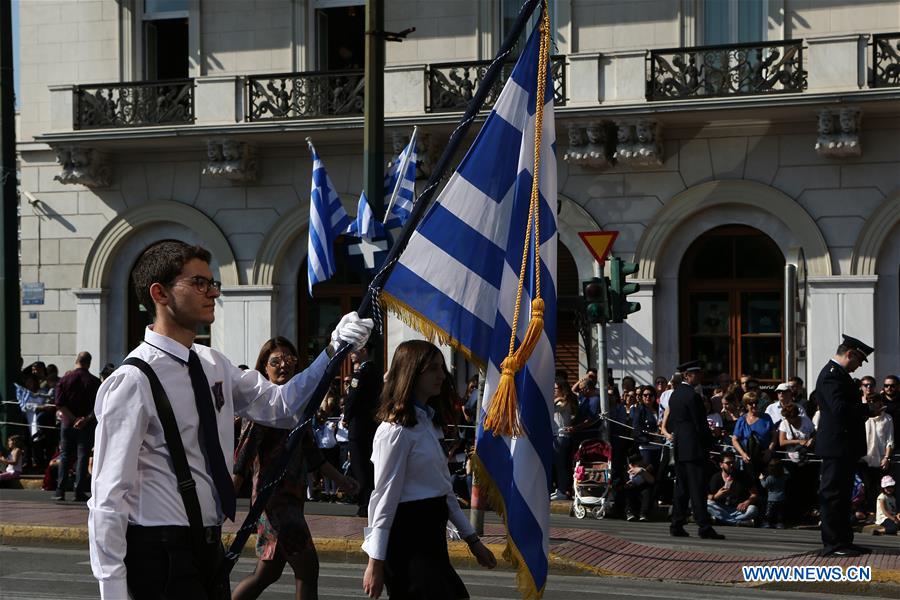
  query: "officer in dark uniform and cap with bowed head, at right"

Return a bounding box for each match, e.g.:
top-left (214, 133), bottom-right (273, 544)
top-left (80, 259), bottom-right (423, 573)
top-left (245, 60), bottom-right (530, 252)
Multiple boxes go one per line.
top-left (816, 335), bottom-right (873, 556)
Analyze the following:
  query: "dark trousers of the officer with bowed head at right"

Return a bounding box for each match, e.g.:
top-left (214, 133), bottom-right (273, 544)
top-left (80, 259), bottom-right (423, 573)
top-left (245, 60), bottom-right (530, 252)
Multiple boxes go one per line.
top-left (819, 458), bottom-right (856, 552)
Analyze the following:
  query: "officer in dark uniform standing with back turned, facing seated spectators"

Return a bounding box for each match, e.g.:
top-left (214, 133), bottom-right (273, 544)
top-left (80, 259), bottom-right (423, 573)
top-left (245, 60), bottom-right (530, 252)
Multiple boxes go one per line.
top-left (665, 361), bottom-right (725, 540)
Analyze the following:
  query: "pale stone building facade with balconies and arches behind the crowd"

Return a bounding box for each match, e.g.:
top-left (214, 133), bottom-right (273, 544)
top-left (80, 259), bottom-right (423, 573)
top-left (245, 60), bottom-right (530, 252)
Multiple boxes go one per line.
top-left (18, 0), bottom-right (900, 382)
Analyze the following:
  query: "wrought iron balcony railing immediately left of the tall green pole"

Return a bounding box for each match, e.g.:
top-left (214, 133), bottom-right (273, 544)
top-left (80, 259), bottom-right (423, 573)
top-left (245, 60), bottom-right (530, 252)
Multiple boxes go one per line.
top-left (247, 71), bottom-right (365, 121)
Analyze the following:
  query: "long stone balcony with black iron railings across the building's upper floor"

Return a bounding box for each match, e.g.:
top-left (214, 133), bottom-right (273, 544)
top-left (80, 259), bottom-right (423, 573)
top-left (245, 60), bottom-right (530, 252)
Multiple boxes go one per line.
top-left (37, 33), bottom-right (900, 143)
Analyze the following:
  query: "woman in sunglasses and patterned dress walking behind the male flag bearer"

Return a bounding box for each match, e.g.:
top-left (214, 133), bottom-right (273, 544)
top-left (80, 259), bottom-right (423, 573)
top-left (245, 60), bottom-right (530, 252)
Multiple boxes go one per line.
top-left (231, 336), bottom-right (357, 600)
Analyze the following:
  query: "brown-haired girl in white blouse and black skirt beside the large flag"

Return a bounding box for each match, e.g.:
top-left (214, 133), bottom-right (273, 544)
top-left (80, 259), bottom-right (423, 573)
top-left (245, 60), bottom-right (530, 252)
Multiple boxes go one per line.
top-left (363, 340), bottom-right (497, 600)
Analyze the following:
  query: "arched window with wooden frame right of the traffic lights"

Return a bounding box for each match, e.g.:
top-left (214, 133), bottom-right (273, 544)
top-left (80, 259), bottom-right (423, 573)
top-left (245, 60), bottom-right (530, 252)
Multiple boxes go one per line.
top-left (679, 225), bottom-right (784, 383)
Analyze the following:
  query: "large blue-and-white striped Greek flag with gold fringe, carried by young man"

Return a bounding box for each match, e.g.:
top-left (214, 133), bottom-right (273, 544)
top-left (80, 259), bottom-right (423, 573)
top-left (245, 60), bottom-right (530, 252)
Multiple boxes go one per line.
top-left (384, 25), bottom-right (557, 598)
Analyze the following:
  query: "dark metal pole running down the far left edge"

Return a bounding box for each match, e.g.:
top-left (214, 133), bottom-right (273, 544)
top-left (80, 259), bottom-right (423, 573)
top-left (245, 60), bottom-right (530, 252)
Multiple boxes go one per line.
top-left (0, 0), bottom-right (20, 440)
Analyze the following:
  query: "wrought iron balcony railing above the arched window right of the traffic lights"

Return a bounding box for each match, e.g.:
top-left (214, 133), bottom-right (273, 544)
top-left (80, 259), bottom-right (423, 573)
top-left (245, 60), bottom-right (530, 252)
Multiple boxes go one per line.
top-left (647, 40), bottom-right (806, 101)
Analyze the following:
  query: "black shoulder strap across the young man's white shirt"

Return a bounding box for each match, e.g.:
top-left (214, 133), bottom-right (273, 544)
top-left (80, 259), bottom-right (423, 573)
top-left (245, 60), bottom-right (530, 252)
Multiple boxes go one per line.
top-left (123, 357), bottom-right (231, 600)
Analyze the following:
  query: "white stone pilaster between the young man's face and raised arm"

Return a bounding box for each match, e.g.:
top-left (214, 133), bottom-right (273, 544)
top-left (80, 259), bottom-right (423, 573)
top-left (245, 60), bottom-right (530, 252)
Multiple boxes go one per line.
top-left (212, 285), bottom-right (275, 367)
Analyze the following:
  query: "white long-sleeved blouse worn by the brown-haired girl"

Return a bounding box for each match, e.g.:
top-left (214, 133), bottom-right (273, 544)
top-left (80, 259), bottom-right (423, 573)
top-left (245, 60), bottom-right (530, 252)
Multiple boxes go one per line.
top-left (362, 406), bottom-right (475, 560)
